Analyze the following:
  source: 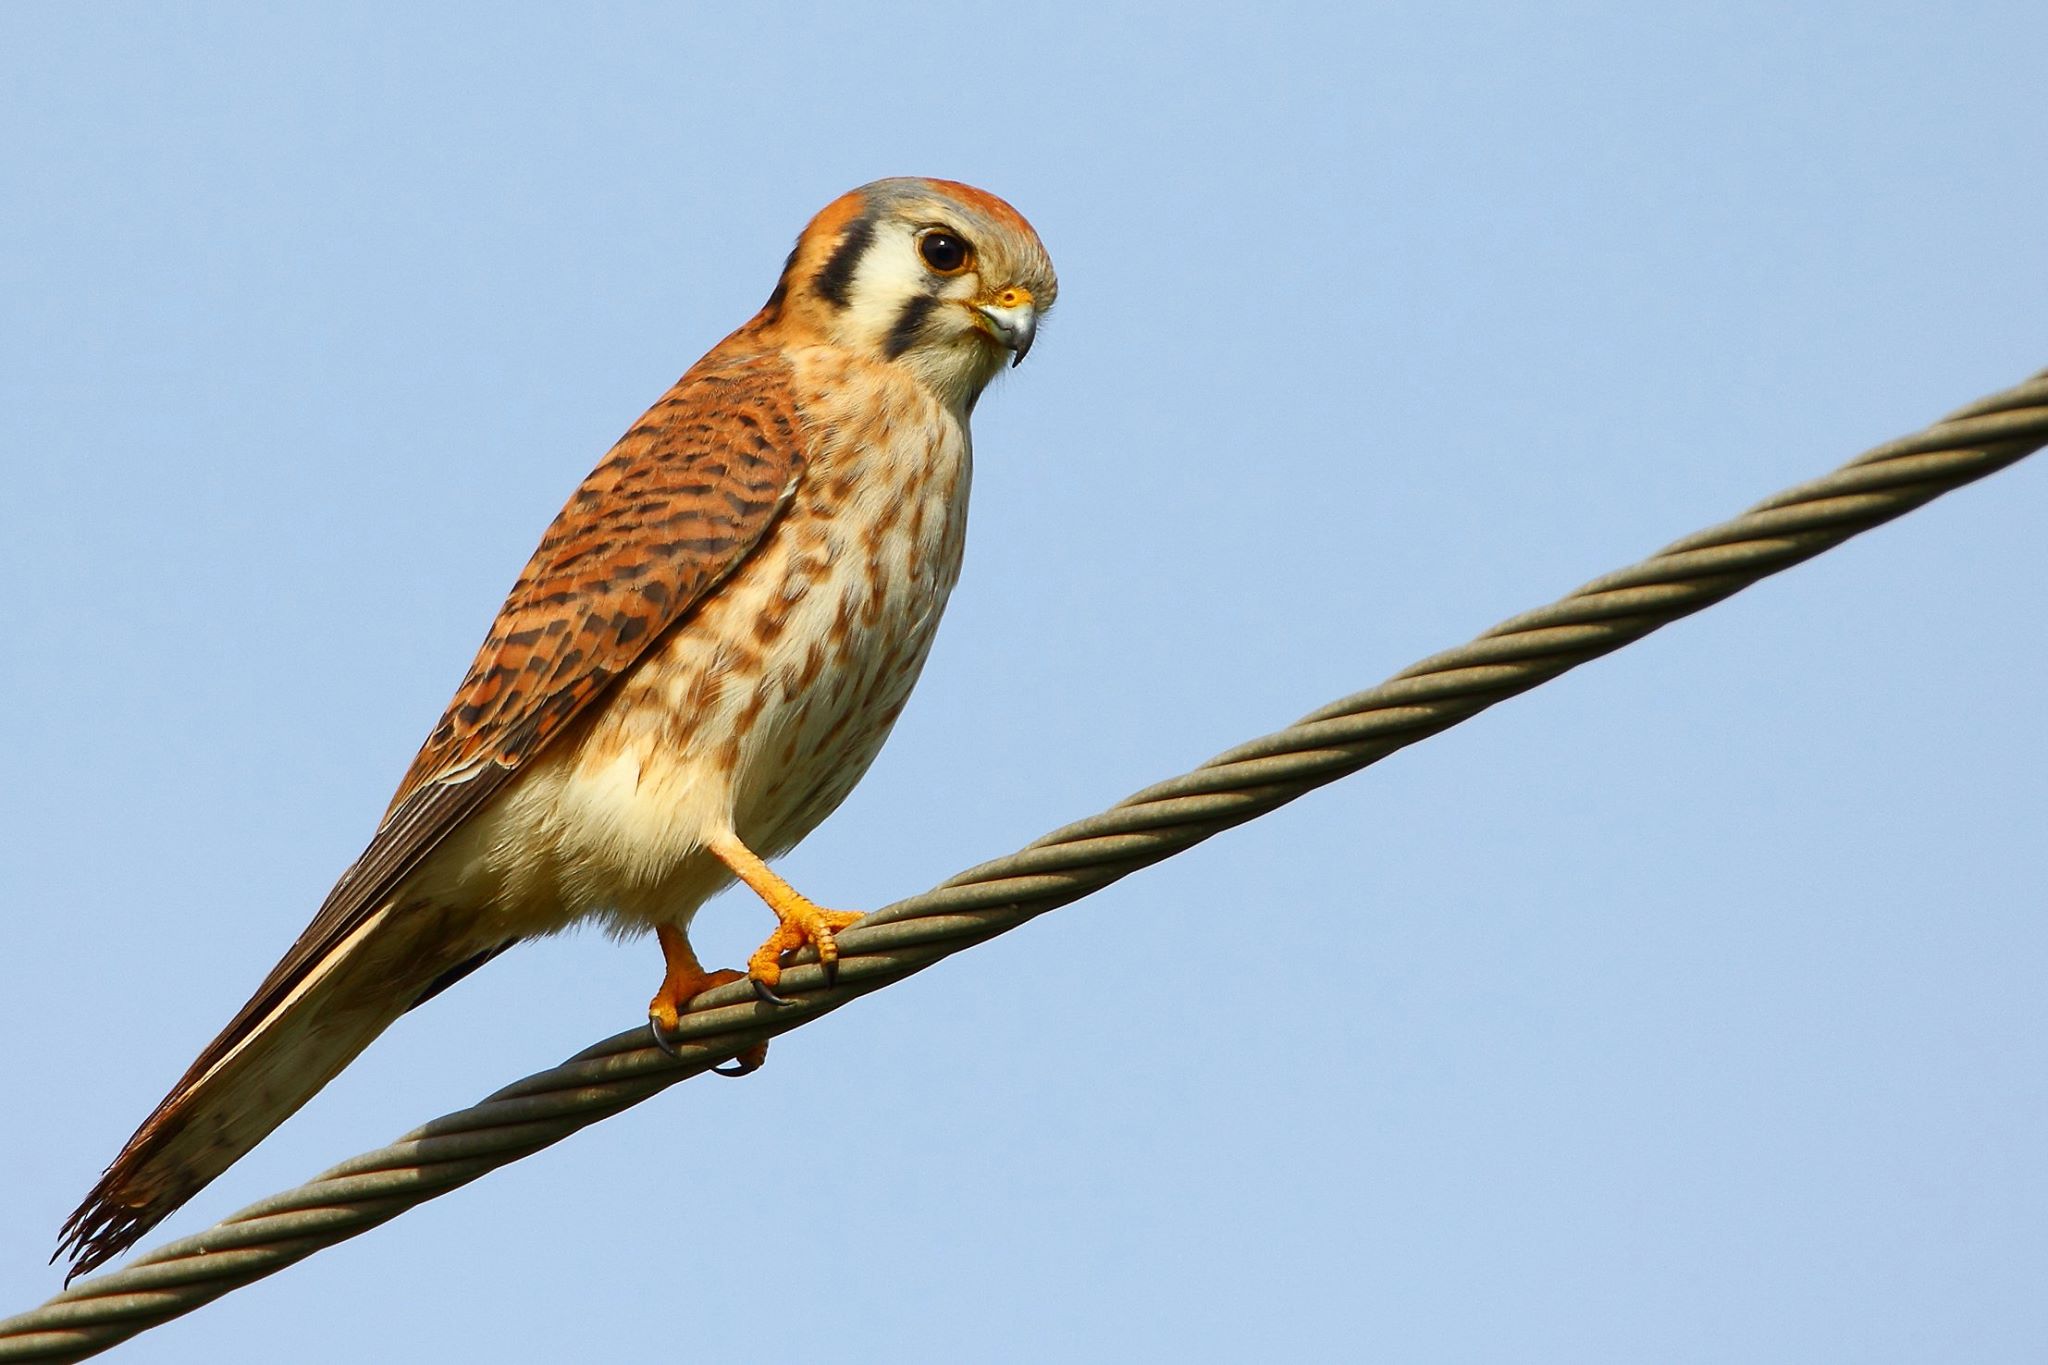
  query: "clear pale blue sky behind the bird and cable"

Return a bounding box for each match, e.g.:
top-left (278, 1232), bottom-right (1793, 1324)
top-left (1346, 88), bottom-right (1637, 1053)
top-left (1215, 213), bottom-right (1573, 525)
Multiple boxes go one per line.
top-left (0, 0), bottom-right (2048, 1363)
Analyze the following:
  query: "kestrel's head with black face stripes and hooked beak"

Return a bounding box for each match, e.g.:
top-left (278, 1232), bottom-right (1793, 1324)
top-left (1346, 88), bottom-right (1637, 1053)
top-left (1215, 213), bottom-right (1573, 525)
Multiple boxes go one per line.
top-left (762, 178), bottom-right (1059, 411)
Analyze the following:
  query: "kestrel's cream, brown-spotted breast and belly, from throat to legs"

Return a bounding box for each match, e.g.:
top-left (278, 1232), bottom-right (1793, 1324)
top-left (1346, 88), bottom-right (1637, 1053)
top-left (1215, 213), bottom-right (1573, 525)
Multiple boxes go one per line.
top-left (528, 354), bottom-right (971, 921)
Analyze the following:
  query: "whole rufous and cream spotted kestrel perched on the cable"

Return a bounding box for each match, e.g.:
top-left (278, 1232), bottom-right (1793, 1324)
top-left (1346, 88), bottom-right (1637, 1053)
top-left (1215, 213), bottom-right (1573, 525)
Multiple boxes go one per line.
top-left (59, 180), bottom-right (1057, 1275)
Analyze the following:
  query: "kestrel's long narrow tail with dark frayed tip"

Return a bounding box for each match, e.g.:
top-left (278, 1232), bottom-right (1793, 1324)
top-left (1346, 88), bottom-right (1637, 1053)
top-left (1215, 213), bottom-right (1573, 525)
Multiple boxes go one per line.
top-left (51, 907), bottom-right (496, 1283)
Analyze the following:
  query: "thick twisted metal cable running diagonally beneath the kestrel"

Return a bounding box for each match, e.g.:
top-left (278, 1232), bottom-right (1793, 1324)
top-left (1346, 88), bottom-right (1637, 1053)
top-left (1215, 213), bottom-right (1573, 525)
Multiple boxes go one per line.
top-left (0, 370), bottom-right (2048, 1363)
